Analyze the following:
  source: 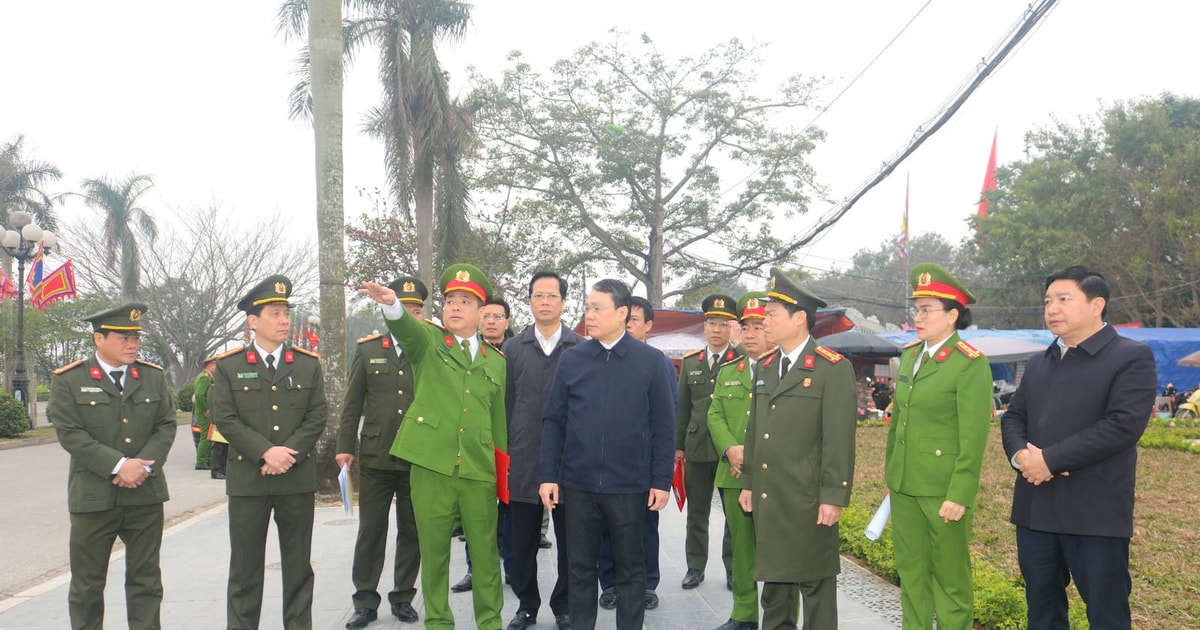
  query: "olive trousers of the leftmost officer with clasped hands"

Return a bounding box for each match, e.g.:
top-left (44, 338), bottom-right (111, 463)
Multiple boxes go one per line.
top-left (67, 503), bottom-right (162, 630)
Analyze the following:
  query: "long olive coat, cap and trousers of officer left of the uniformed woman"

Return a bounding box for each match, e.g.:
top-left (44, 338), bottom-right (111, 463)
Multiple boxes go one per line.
top-left (742, 269), bottom-right (856, 630)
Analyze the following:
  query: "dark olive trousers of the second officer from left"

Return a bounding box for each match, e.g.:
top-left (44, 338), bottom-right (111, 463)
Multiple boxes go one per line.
top-left (226, 492), bottom-right (313, 630)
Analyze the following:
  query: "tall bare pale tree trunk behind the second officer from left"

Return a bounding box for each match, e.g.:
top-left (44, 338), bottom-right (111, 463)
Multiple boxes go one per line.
top-left (308, 0), bottom-right (347, 485)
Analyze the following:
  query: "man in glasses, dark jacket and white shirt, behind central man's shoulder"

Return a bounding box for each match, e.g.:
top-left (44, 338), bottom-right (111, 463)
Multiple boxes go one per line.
top-left (504, 271), bottom-right (583, 630)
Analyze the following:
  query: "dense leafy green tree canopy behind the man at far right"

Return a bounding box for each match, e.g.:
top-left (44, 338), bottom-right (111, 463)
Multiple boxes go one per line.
top-left (976, 94), bottom-right (1200, 326)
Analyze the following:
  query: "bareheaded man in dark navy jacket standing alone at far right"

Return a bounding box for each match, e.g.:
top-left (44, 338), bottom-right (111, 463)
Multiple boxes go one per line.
top-left (1001, 266), bottom-right (1157, 630)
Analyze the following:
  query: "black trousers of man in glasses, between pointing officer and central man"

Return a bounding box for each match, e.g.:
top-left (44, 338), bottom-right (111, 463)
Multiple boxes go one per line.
top-left (509, 502), bottom-right (568, 617)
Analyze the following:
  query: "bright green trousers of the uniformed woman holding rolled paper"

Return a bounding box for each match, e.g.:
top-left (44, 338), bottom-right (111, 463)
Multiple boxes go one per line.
top-left (892, 492), bottom-right (974, 630)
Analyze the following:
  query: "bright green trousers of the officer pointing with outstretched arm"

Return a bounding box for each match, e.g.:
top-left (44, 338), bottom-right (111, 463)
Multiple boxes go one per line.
top-left (410, 464), bottom-right (504, 630)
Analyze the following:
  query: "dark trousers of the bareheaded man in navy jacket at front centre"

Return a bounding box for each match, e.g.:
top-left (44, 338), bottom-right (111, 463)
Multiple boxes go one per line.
top-left (562, 488), bottom-right (649, 630)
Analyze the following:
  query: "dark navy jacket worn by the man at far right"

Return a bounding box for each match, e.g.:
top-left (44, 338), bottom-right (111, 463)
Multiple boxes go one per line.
top-left (1001, 324), bottom-right (1158, 538)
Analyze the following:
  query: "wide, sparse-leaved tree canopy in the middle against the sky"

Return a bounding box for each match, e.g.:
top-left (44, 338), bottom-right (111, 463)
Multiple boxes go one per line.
top-left (472, 32), bottom-right (822, 305)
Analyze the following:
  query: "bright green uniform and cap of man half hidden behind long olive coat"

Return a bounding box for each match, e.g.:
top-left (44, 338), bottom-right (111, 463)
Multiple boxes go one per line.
top-left (708, 292), bottom-right (767, 624)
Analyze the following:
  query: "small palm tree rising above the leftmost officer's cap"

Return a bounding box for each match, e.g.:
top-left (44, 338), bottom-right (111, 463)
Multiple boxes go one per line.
top-left (83, 173), bottom-right (158, 300)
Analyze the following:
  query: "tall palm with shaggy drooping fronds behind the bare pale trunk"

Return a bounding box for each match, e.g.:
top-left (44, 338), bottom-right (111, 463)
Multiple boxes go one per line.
top-left (278, 0), bottom-right (470, 290)
